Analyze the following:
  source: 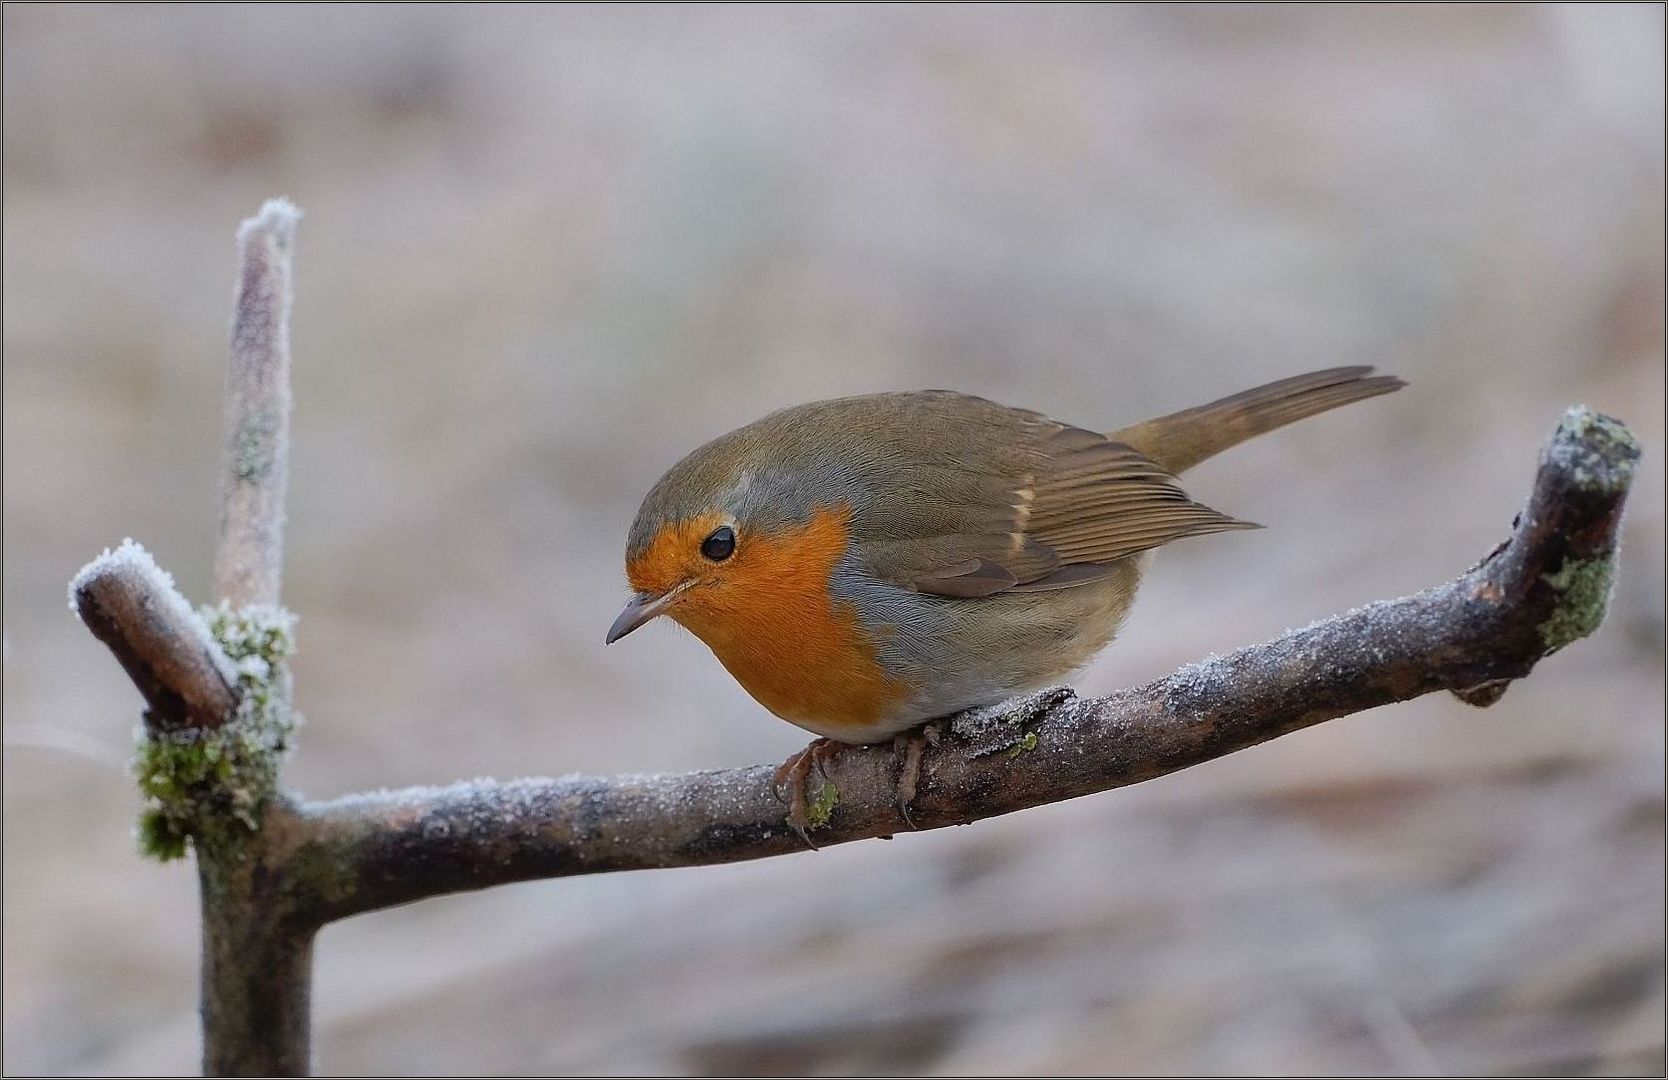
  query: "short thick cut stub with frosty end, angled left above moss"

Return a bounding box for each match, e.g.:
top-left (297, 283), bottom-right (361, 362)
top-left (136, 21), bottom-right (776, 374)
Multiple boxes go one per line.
top-left (70, 539), bottom-right (237, 731)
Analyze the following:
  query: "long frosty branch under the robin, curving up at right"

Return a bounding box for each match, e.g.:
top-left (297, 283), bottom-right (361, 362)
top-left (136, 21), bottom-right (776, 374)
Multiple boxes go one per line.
top-left (270, 407), bottom-right (1640, 923)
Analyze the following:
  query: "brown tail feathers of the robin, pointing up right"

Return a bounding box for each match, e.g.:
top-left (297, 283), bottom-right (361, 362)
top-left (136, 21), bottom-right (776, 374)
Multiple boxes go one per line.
top-left (1108, 367), bottom-right (1406, 472)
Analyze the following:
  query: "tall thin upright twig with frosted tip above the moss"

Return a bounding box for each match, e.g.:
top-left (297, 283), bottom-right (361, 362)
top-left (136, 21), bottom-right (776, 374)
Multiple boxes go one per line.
top-left (214, 199), bottom-right (300, 608)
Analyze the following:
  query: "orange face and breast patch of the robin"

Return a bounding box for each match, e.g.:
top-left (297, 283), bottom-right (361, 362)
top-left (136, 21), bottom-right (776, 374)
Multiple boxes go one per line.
top-left (627, 506), bottom-right (909, 738)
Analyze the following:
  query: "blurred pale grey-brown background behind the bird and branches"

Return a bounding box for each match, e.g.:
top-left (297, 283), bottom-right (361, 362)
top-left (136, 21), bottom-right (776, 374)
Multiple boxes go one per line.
top-left (3, 5), bottom-right (1665, 1073)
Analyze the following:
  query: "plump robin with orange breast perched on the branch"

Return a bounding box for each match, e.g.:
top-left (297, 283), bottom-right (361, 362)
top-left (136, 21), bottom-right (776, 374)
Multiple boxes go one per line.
top-left (607, 367), bottom-right (1404, 843)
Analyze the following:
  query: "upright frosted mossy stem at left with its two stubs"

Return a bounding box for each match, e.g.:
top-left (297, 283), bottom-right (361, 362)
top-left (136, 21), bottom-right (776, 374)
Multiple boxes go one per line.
top-left (70, 199), bottom-right (314, 1075)
